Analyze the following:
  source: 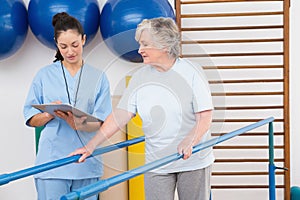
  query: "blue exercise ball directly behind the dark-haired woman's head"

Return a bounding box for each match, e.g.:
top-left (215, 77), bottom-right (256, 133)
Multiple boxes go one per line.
top-left (28, 0), bottom-right (100, 49)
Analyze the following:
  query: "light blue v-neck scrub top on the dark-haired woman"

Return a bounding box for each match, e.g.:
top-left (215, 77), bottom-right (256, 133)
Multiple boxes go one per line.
top-left (24, 61), bottom-right (112, 179)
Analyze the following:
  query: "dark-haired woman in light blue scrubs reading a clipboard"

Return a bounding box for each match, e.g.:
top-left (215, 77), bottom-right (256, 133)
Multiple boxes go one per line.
top-left (24, 12), bottom-right (112, 200)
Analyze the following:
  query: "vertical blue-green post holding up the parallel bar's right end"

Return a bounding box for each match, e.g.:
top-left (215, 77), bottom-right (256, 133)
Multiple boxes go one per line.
top-left (269, 122), bottom-right (276, 200)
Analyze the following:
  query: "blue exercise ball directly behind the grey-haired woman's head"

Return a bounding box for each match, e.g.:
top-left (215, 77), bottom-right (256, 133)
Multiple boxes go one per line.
top-left (100, 0), bottom-right (175, 62)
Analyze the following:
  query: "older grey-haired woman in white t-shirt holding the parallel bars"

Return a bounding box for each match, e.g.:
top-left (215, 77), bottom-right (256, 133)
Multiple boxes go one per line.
top-left (71, 18), bottom-right (214, 200)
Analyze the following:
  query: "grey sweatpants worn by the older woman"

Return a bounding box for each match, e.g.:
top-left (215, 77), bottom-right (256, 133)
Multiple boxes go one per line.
top-left (144, 166), bottom-right (211, 200)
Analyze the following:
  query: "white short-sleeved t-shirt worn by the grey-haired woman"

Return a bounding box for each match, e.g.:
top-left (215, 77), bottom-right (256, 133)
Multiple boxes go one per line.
top-left (118, 58), bottom-right (214, 173)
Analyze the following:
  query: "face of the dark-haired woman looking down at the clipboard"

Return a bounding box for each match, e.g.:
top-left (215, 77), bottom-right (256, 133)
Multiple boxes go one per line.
top-left (57, 29), bottom-right (86, 64)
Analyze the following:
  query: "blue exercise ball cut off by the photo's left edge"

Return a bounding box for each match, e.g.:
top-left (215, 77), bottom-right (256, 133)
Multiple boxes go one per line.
top-left (0, 0), bottom-right (28, 59)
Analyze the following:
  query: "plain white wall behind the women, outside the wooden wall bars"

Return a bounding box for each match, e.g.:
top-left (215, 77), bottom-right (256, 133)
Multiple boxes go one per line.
top-left (0, 0), bottom-right (300, 199)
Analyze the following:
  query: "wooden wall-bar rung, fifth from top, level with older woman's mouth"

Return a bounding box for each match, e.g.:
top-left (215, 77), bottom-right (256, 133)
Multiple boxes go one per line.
top-left (182, 52), bottom-right (284, 58)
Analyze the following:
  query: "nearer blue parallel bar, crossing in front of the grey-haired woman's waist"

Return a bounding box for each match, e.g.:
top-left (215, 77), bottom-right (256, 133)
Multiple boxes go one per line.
top-left (61, 117), bottom-right (274, 200)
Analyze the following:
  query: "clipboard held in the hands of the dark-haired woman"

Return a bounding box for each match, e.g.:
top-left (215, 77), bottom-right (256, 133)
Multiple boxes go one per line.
top-left (32, 104), bottom-right (101, 122)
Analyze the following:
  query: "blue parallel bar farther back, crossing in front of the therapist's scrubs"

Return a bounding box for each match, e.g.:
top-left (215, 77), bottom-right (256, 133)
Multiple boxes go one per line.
top-left (0, 136), bottom-right (145, 186)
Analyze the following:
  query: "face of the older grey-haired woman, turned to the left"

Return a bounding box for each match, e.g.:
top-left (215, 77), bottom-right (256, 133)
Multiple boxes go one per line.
top-left (139, 30), bottom-right (166, 65)
